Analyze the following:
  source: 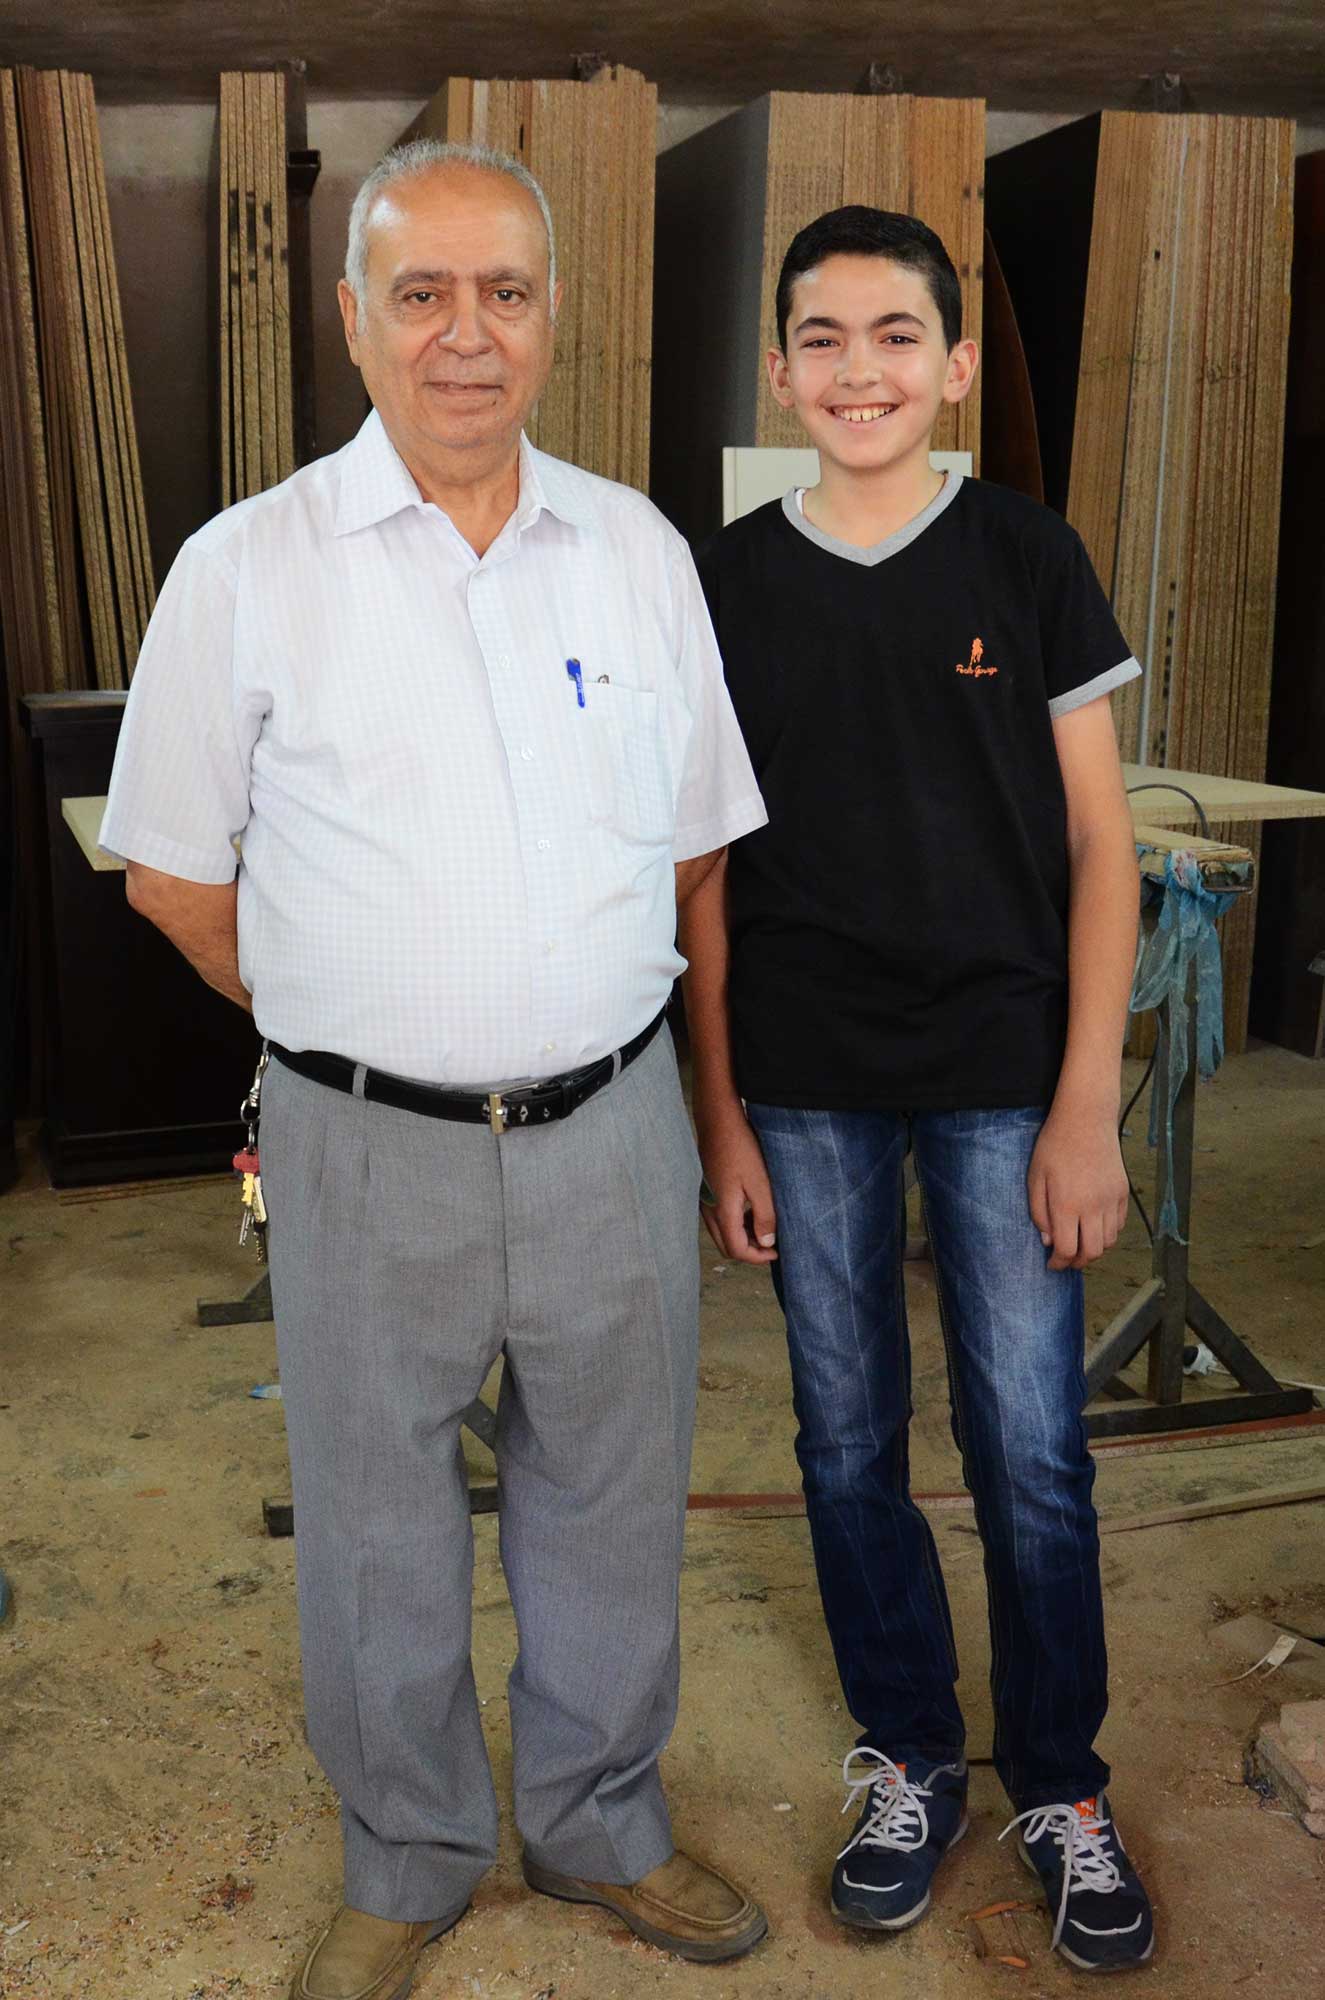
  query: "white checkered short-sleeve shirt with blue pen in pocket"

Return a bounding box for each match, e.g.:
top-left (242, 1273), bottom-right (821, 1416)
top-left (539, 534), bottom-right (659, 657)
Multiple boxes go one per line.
top-left (102, 414), bottom-right (767, 1086)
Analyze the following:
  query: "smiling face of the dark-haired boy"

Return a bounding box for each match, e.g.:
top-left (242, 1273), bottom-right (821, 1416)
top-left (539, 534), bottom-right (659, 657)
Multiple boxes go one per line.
top-left (769, 254), bottom-right (975, 486)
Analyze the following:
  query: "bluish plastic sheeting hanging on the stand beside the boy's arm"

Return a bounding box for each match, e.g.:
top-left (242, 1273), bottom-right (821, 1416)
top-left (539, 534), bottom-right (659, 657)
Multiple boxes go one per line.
top-left (1131, 846), bottom-right (1251, 1242)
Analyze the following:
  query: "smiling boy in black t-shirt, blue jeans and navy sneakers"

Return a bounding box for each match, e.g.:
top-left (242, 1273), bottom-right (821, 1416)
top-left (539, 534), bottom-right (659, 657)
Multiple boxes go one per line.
top-left (683, 208), bottom-right (1153, 1970)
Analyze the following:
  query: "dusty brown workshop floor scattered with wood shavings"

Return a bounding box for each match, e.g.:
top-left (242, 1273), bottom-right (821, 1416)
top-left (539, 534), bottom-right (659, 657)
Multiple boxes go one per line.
top-left (0, 1050), bottom-right (1325, 2000)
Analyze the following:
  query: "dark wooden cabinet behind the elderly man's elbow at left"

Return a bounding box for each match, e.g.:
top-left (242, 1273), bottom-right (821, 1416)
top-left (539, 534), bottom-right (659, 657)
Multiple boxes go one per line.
top-left (22, 692), bottom-right (258, 1188)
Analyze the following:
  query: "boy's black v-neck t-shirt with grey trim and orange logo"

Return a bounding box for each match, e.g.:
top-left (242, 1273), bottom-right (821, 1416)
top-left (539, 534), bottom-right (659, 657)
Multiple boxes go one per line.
top-left (697, 474), bottom-right (1141, 1110)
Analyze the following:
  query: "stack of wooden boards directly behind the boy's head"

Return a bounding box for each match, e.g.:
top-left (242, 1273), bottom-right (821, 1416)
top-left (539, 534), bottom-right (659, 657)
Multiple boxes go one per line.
top-left (652, 90), bottom-right (985, 538)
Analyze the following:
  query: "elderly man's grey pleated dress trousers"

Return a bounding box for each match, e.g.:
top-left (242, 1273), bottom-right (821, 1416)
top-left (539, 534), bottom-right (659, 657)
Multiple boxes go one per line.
top-left (262, 1028), bottom-right (699, 1922)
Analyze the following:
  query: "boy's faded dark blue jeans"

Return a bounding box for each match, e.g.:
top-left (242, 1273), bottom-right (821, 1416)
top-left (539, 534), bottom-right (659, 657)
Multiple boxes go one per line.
top-left (749, 1104), bottom-right (1109, 1808)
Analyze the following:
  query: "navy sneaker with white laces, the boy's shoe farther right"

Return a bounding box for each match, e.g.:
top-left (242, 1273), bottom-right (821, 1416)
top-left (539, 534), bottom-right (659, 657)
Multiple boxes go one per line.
top-left (1012, 1792), bottom-right (1155, 1972)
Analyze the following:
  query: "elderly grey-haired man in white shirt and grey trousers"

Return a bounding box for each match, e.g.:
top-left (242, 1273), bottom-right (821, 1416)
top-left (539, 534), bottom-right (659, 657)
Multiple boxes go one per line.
top-left (102, 142), bottom-right (767, 2000)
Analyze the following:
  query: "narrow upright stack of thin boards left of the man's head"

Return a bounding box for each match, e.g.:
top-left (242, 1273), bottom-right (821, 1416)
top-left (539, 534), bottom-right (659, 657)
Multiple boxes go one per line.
top-left (220, 70), bottom-right (294, 506)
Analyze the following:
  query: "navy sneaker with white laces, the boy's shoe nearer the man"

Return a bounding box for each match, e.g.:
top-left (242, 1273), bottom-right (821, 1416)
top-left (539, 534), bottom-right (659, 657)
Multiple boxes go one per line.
top-left (831, 1750), bottom-right (969, 1930)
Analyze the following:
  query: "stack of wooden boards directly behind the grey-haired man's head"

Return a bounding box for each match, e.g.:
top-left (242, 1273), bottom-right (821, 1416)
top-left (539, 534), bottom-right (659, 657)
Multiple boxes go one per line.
top-left (406, 68), bottom-right (658, 488)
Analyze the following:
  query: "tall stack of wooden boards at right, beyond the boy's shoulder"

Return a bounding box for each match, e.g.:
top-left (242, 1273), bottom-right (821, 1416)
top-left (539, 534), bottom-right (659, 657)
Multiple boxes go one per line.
top-left (987, 112), bottom-right (1293, 1050)
